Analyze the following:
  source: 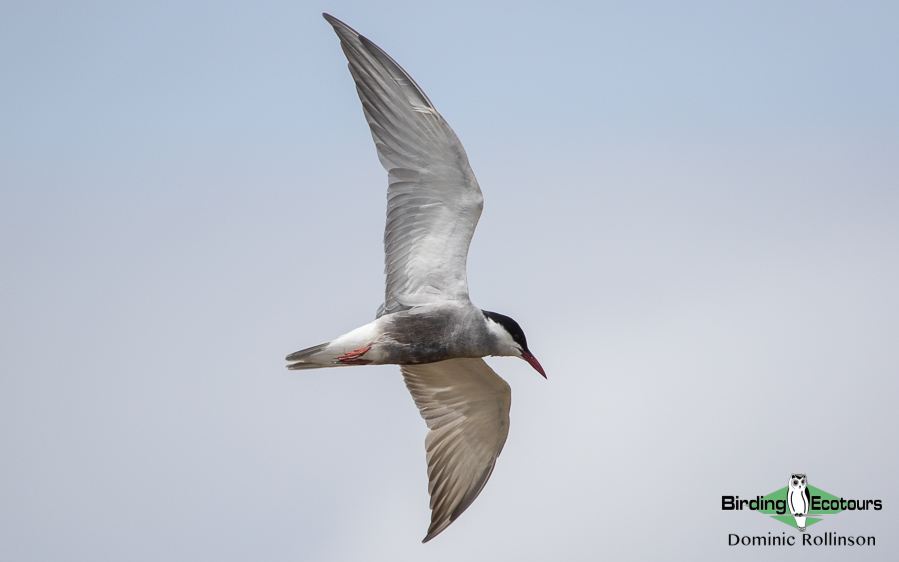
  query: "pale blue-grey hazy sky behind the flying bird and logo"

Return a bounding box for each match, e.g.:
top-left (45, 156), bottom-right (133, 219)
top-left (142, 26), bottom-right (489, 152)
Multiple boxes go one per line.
top-left (0, 0), bottom-right (899, 561)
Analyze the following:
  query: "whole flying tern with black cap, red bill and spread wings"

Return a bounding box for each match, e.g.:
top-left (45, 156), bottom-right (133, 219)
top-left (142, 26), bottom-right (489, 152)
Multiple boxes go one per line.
top-left (287, 14), bottom-right (546, 542)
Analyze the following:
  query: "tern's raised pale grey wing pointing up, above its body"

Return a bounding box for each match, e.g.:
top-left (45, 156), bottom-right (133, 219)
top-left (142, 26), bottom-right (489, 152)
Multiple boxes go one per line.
top-left (324, 14), bottom-right (483, 316)
